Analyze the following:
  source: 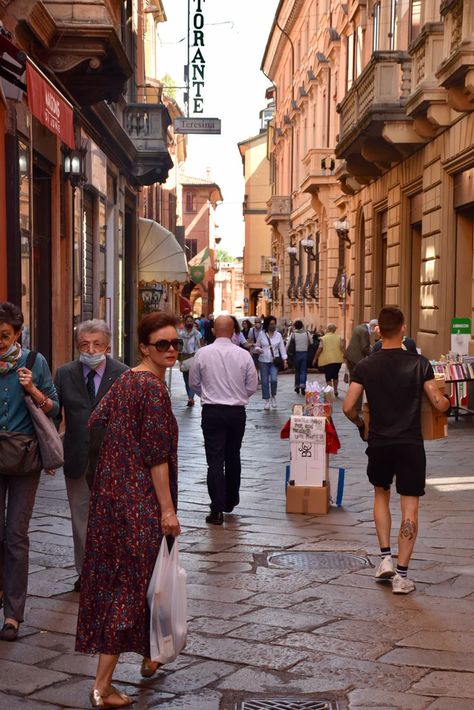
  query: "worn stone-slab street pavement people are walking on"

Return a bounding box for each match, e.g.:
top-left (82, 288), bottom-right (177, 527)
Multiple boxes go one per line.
top-left (0, 371), bottom-right (474, 710)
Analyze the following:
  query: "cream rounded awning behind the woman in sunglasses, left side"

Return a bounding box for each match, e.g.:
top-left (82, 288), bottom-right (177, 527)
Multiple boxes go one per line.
top-left (138, 217), bottom-right (188, 283)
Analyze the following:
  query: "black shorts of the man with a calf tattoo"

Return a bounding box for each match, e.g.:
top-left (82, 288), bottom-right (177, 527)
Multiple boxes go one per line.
top-left (365, 443), bottom-right (426, 496)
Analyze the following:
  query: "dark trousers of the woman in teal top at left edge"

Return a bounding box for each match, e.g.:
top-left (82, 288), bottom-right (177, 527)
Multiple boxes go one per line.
top-left (0, 473), bottom-right (40, 621)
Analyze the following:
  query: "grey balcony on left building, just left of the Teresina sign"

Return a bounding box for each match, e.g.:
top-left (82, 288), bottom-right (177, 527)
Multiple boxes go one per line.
top-left (123, 103), bottom-right (173, 185)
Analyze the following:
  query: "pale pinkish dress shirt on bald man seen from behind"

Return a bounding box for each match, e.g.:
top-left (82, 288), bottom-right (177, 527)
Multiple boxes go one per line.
top-left (189, 338), bottom-right (258, 407)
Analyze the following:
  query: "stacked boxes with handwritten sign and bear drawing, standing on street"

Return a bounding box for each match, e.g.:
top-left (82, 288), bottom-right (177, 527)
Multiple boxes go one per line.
top-left (286, 415), bottom-right (329, 515)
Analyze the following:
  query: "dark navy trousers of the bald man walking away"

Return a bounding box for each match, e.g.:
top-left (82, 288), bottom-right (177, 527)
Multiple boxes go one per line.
top-left (201, 404), bottom-right (246, 513)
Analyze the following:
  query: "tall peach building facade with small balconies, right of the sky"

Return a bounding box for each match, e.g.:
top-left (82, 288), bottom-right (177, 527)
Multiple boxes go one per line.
top-left (261, 0), bottom-right (348, 335)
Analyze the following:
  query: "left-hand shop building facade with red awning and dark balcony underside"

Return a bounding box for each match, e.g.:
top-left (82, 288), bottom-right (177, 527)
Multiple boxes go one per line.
top-left (0, 0), bottom-right (179, 369)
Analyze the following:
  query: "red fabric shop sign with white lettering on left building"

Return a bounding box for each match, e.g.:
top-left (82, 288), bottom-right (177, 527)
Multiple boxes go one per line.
top-left (26, 61), bottom-right (75, 149)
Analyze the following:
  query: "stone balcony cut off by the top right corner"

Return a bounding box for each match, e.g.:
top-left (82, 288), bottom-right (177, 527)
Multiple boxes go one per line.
top-left (436, 0), bottom-right (474, 112)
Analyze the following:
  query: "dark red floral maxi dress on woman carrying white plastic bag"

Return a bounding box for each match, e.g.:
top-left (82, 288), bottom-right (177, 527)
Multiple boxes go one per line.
top-left (76, 370), bottom-right (178, 656)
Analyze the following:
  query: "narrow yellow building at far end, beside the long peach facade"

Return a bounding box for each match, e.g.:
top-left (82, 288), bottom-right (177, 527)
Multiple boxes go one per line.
top-left (238, 124), bottom-right (272, 316)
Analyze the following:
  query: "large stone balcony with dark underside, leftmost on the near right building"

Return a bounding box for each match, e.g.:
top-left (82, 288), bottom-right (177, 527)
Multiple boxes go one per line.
top-left (336, 51), bottom-right (425, 184)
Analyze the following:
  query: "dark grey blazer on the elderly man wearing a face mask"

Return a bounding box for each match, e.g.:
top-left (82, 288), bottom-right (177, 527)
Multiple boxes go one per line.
top-left (54, 357), bottom-right (128, 478)
